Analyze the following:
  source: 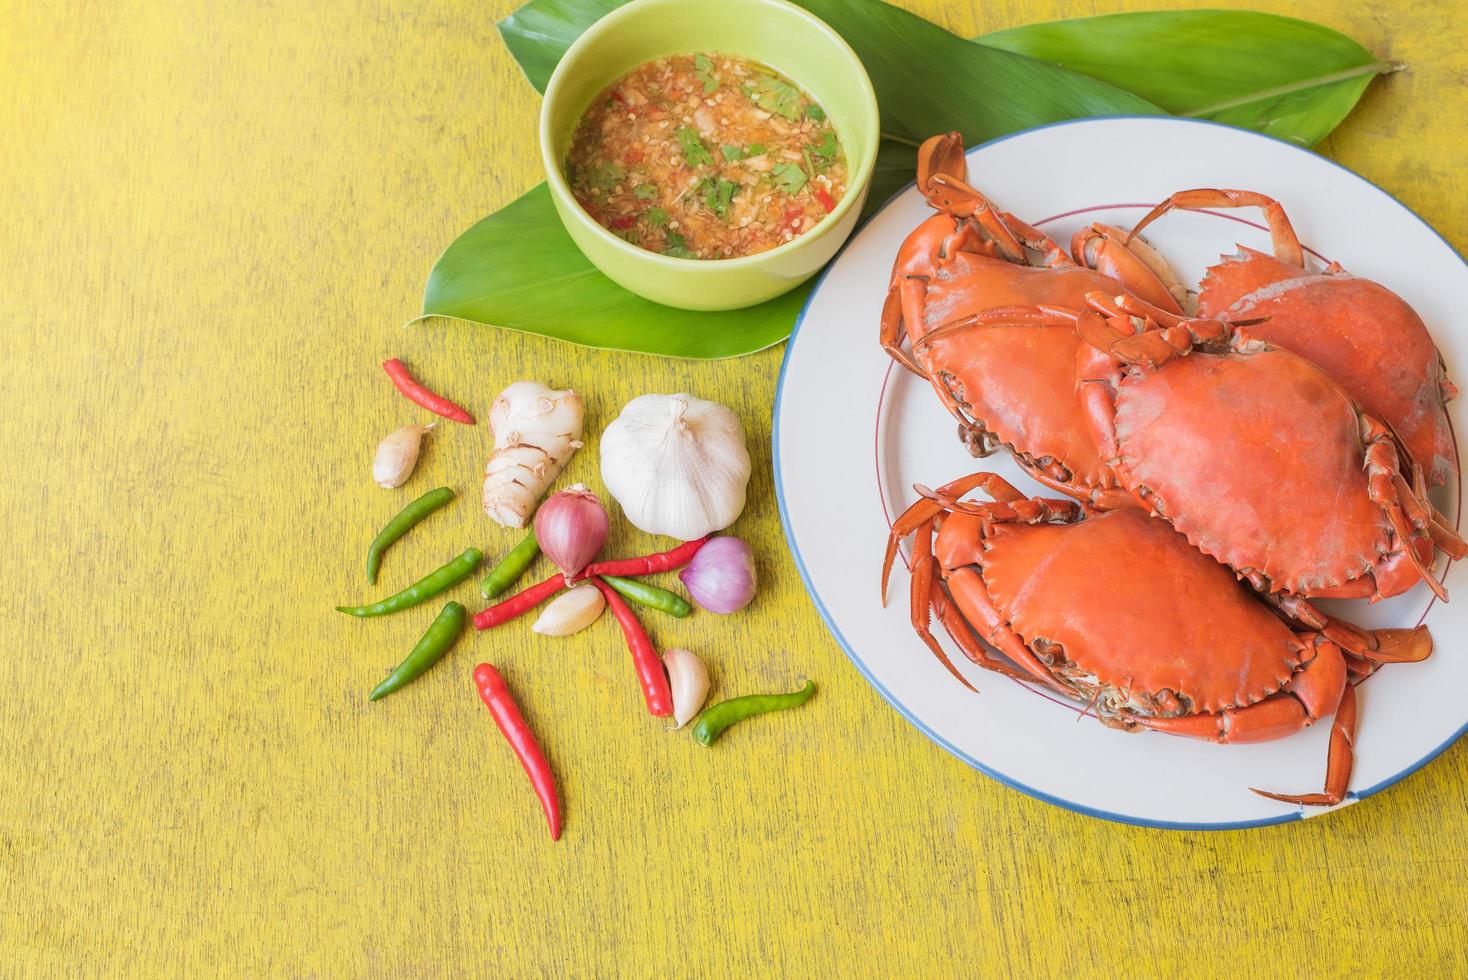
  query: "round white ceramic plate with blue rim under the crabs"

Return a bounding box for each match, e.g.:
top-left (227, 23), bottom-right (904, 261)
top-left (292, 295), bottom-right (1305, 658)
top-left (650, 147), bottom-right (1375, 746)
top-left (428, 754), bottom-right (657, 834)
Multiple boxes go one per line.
top-left (774, 117), bottom-right (1468, 829)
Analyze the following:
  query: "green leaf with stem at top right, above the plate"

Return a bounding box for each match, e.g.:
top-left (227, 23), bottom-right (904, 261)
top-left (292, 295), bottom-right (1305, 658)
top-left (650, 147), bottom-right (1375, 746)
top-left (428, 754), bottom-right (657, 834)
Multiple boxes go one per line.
top-left (975, 10), bottom-right (1396, 147)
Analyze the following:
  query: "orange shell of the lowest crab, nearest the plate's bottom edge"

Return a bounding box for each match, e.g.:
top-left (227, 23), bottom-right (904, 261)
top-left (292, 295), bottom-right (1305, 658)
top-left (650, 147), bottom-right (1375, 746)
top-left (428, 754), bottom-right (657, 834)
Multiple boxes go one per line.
top-left (957, 508), bottom-right (1314, 714)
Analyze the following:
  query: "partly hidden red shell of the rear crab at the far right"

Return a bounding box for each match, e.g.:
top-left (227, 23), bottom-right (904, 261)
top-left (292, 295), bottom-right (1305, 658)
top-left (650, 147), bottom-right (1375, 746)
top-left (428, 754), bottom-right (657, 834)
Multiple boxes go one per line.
top-left (1198, 246), bottom-right (1458, 486)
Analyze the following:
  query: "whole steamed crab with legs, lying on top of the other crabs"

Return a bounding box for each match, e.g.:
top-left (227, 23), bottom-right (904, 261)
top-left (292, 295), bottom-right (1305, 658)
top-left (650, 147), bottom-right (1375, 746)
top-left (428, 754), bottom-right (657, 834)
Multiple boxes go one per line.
top-left (1082, 296), bottom-right (1462, 600)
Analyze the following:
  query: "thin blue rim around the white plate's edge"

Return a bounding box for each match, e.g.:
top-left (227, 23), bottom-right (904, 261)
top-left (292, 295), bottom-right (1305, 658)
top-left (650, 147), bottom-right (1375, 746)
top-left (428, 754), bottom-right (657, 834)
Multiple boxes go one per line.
top-left (769, 116), bottom-right (1468, 830)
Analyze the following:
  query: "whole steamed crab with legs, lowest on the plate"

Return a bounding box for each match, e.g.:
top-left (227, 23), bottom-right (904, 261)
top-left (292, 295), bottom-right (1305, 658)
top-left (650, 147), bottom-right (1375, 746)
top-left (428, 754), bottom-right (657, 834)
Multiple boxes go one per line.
top-left (882, 472), bottom-right (1431, 805)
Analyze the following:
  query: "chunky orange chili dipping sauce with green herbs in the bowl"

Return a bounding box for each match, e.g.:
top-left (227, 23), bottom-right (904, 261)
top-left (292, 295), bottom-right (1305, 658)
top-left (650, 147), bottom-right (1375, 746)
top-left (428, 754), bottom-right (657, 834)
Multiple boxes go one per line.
top-left (565, 54), bottom-right (846, 258)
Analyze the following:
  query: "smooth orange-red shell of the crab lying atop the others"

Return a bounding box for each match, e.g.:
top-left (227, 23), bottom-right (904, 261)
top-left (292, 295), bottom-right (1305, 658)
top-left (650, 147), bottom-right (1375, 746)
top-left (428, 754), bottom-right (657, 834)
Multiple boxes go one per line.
top-left (1116, 348), bottom-right (1397, 594)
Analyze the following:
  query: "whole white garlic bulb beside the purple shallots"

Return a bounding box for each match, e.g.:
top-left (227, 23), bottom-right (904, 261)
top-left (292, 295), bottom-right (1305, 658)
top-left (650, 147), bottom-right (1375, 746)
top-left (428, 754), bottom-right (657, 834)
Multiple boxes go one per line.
top-left (602, 393), bottom-right (750, 541)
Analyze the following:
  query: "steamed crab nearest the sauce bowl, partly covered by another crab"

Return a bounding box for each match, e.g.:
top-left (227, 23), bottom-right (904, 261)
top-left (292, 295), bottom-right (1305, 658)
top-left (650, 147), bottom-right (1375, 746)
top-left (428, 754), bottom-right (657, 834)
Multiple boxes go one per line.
top-left (881, 134), bottom-right (1186, 503)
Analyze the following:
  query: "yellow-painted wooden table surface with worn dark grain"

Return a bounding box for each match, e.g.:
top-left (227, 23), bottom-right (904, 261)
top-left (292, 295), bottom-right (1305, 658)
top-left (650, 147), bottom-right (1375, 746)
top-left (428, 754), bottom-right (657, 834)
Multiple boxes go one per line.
top-left (0, 0), bottom-right (1468, 977)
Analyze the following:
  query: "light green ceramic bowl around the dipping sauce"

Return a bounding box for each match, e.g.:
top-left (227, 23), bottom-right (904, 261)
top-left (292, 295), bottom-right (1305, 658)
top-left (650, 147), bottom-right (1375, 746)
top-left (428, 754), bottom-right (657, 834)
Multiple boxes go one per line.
top-left (540, 0), bottom-right (878, 310)
